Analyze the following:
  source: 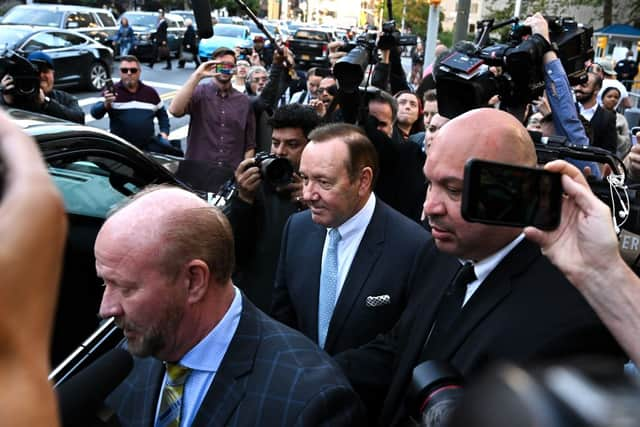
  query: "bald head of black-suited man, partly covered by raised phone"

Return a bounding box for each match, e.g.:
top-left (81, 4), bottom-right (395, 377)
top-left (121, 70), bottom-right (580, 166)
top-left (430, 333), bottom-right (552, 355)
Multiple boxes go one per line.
top-left (424, 108), bottom-right (536, 261)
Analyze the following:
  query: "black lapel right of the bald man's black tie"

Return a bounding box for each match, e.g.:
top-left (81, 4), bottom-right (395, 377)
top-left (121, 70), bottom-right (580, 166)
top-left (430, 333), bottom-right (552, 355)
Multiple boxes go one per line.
top-left (438, 239), bottom-right (540, 360)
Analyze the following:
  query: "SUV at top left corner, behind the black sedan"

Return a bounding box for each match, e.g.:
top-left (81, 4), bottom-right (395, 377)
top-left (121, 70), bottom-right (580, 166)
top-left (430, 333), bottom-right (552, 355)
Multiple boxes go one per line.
top-left (1, 3), bottom-right (118, 46)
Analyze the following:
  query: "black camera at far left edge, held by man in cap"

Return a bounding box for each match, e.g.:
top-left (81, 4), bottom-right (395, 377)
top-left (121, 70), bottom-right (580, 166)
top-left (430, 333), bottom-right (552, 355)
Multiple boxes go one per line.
top-left (0, 51), bottom-right (40, 102)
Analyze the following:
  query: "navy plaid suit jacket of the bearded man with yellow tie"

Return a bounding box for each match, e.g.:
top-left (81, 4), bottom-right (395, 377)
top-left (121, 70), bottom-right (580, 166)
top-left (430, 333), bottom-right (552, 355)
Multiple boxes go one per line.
top-left (107, 297), bottom-right (363, 427)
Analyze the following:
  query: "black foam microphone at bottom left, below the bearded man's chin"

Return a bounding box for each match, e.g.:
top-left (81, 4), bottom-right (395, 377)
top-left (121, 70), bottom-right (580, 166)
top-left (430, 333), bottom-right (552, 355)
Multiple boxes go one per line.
top-left (56, 348), bottom-right (133, 427)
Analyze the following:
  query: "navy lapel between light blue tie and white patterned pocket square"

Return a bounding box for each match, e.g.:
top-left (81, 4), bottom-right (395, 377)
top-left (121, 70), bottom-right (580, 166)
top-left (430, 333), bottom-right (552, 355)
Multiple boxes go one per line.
top-left (324, 199), bottom-right (387, 351)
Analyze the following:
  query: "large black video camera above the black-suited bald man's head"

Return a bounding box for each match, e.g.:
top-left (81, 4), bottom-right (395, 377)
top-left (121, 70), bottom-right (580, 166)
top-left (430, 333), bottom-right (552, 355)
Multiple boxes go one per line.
top-left (435, 17), bottom-right (593, 118)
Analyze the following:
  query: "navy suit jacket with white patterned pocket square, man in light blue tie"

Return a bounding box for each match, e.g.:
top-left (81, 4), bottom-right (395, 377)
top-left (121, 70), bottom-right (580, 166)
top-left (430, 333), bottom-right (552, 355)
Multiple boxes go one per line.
top-left (272, 199), bottom-right (429, 354)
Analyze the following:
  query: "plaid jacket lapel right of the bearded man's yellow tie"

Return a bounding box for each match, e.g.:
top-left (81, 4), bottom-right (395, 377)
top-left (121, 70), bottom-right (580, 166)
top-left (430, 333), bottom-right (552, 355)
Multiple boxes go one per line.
top-left (193, 294), bottom-right (262, 427)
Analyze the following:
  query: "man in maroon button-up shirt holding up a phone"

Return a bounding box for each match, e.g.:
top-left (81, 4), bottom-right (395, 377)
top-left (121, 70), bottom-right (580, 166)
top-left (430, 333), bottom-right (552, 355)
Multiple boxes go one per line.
top-left (169, 47), bottom-right (256, 171)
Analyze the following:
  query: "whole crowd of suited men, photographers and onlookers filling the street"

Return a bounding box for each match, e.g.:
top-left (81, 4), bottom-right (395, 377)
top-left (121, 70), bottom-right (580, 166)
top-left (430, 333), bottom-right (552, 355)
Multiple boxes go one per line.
top-left (6, 8), bottom-right (640, 426)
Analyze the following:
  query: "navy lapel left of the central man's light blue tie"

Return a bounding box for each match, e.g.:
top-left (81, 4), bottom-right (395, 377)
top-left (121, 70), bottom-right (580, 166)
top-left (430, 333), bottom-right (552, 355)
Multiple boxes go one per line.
top-left (304, 223), bottom-right (327, 342)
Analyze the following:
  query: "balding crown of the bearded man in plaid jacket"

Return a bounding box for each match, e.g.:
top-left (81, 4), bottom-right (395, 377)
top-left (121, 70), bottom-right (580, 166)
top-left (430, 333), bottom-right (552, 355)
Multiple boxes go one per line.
top-left (96, 186), bottom-right (234, 284)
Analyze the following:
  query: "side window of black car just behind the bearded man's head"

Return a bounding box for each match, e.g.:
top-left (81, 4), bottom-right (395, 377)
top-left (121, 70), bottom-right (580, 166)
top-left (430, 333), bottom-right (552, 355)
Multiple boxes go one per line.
top-left (49, 154), bottom-right (143, 218)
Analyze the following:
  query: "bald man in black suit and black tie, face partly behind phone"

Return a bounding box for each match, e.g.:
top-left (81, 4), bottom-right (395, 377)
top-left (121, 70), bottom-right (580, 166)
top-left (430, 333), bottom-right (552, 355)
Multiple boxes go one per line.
top-left (337, 108), bottom-right (622, 426)
